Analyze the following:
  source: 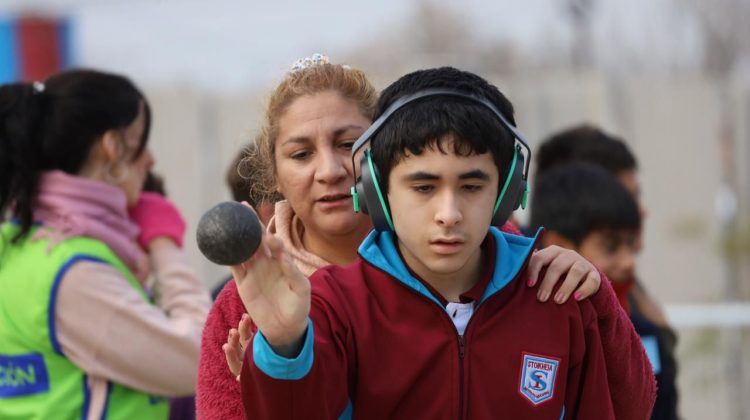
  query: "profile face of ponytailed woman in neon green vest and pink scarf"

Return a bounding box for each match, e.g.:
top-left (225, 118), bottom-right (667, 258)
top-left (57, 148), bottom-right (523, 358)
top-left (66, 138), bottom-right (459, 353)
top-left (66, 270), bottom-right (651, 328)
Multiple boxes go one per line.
top-left (117, 104), bottom-right (154, 207)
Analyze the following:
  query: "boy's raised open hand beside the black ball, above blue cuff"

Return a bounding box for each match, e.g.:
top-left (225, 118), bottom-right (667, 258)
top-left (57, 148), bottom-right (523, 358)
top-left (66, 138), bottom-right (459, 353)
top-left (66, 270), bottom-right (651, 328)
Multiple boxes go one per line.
top-left (230, 235), bottom-right (310, 357)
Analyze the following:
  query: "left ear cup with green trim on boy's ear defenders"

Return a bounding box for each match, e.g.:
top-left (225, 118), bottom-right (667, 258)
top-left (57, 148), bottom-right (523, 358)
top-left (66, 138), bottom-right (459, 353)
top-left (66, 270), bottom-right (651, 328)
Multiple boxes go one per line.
top-left (353, 149), bottom-right (394, 231)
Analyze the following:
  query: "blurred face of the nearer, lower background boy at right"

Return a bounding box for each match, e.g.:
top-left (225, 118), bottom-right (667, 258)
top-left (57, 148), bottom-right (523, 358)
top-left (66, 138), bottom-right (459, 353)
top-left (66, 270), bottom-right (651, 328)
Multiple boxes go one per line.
top-left (578, 230), bottom-right (638, 283)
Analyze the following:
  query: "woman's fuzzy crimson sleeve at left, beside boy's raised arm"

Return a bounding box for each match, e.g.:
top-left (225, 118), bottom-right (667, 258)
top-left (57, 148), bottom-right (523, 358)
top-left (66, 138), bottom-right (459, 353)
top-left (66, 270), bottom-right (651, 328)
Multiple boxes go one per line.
top-left (196, 281), bottom-right (245, 420)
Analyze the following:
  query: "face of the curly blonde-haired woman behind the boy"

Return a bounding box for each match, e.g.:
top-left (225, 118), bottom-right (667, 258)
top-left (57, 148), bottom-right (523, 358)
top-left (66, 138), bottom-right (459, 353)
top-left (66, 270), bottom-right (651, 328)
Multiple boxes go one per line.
top-left (274, 91), bottom-right (370, 237)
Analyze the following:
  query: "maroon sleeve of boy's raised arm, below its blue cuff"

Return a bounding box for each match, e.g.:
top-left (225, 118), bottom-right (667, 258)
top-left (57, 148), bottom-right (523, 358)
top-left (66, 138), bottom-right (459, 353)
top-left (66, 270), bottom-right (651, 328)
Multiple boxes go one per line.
top-left (240, 278), bottom-right (351, 420)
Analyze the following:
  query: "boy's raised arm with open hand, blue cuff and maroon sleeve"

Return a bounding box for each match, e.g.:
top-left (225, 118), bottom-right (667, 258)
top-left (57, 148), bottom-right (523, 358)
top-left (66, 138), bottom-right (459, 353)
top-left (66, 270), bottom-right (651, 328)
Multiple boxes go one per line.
top-left (232, 235), bottom-right (351, 419)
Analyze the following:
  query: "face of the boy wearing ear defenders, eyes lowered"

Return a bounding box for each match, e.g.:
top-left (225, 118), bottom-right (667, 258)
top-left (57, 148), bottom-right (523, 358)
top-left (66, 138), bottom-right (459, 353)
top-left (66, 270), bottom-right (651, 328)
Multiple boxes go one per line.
top-left (388, 135), bottom-right (499, 282)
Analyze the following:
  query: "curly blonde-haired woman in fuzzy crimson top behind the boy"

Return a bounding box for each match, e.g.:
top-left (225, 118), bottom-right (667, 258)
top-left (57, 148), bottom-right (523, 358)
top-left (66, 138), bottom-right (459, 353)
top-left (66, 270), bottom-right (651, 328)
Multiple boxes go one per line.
top-left (197, 55), bottom-right (650, 419)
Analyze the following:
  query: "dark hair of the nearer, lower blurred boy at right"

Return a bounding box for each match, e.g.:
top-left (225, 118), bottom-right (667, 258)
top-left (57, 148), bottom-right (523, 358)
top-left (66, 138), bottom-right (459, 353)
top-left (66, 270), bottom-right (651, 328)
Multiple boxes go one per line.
top-left (531, 162), bottom-right (641, 246)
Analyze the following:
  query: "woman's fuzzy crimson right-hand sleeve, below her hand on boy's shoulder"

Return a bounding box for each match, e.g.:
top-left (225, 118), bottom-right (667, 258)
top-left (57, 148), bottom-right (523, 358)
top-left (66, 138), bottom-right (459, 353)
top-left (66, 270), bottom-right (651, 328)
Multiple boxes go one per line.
top-left (590, 273), bottom-right (656, 420)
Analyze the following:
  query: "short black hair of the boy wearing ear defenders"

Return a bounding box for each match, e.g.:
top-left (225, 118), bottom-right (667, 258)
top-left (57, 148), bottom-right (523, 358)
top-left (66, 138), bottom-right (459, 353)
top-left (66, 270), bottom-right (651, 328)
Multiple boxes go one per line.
top-left (370, 67), bottom-right (515, 193)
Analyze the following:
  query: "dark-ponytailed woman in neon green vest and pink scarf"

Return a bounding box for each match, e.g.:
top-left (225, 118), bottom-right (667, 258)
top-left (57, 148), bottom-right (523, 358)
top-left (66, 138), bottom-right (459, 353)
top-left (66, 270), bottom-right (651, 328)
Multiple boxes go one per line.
top-left (0, 70), bottom-right (211, 419)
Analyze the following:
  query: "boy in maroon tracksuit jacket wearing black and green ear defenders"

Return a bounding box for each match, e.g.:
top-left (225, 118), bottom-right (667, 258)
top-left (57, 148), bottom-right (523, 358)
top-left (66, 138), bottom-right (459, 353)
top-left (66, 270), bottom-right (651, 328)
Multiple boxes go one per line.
top-left (233, 68), bottom-right (645, 419)
